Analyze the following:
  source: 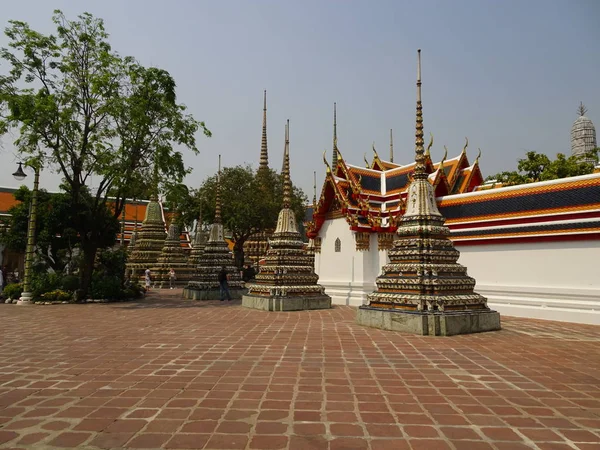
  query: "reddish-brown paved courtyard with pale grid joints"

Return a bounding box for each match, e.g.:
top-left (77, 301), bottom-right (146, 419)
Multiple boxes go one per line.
top-left (0, 290), bottom-right (600, 450)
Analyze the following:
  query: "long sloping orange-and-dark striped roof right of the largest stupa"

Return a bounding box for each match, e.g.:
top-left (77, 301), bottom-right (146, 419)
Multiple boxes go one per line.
top-left (437, 173), bottom-right (600, 245)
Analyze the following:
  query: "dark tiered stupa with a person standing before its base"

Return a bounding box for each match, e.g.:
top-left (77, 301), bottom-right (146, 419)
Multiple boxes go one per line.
top-left (183, 155), bottom-right (244, 300)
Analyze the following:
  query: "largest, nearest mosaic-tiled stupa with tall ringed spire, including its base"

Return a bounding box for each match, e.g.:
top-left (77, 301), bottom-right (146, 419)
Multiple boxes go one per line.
top-left (356, 50), bottom-right (500, 336)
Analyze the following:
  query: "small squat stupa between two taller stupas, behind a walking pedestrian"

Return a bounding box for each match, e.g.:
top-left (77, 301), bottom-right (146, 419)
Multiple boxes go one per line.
top-left (150, 223), bottom-right (194, 288)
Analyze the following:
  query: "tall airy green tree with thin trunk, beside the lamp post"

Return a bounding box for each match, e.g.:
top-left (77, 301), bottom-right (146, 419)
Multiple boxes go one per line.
top-left (0, 11), bottom-right (210, 292)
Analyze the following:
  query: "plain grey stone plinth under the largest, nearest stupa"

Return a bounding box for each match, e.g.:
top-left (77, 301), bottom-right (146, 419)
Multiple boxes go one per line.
top-left (356, 306), bottom-right (501, 336)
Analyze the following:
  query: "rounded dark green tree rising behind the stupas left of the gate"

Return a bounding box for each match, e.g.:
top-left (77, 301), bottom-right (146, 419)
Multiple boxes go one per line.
top-left (195, 166), bottom-right (307, 267)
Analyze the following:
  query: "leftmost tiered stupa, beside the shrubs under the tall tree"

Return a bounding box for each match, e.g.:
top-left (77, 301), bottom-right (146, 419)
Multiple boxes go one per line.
top-left (125, 194), bottom-right (166, 280)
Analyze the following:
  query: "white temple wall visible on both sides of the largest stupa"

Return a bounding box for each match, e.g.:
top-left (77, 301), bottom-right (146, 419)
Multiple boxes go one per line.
top-left (315, 223), bottom-right (600, 325)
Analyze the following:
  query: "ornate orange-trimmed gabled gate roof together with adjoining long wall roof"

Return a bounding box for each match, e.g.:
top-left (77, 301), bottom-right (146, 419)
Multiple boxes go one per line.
top-left (305, 103), bottom-right (600, 245)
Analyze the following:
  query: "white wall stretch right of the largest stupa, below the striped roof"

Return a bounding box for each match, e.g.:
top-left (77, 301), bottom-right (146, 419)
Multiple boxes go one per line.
top-left (457, 240), bottom-right (600, 325)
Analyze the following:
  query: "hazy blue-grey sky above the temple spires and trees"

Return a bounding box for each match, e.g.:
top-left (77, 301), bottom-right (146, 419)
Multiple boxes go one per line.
top-left (0, 0), bottom-right (600, 198)
